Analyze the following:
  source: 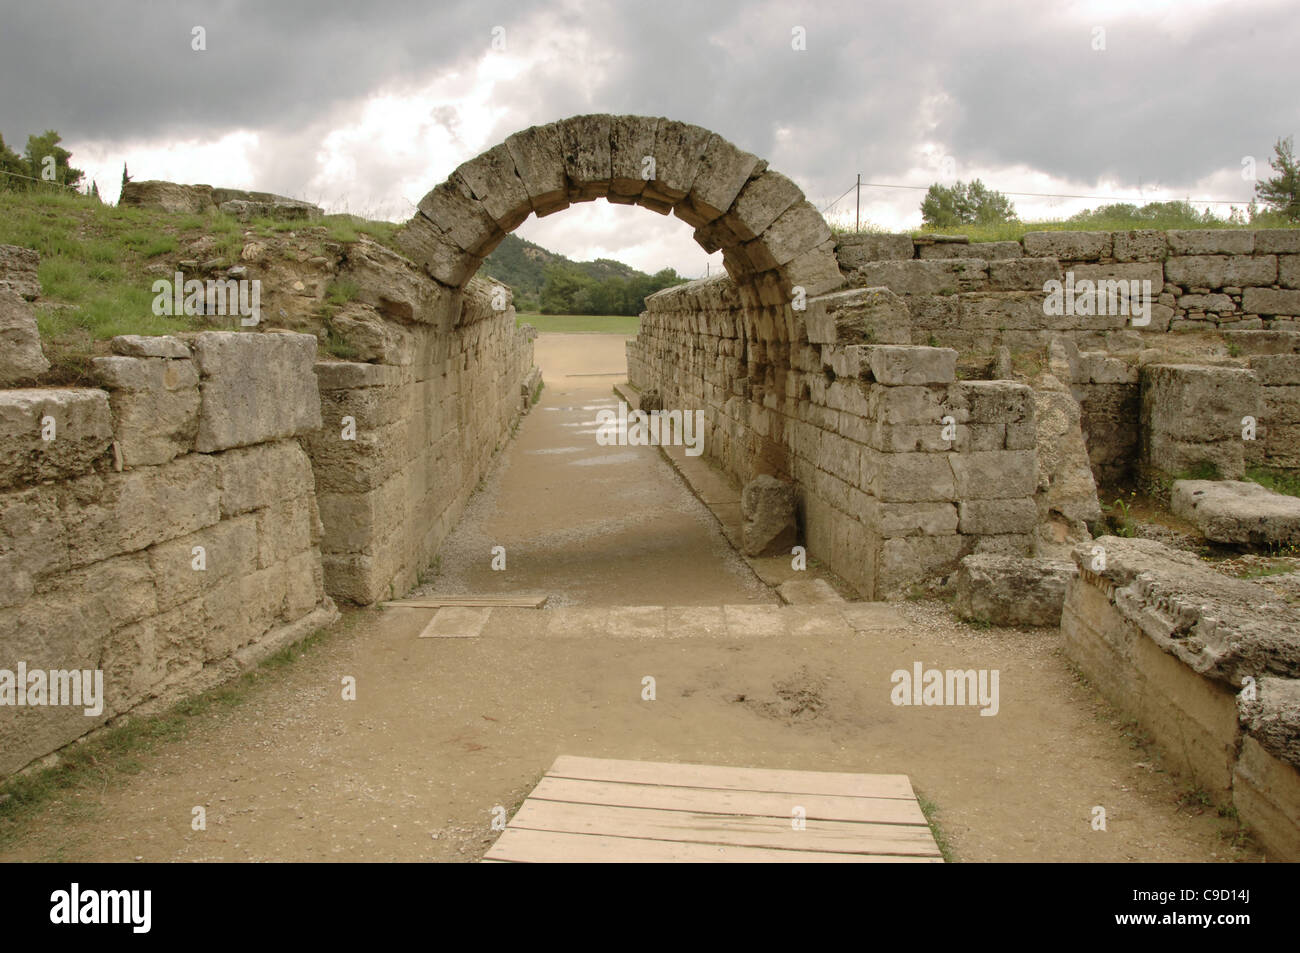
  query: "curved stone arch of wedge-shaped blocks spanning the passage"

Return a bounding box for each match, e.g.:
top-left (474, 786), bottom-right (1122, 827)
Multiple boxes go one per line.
top-left (399, 114), bottom-right (844, 315)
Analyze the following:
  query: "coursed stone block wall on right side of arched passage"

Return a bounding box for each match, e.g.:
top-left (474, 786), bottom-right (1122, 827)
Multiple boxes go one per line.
top-left (628, 278), bottom-right (1036, 598)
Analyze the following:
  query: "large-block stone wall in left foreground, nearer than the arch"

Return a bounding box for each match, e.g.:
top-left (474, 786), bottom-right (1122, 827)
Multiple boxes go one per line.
top-left (0, 332), bottom-right (337, 776)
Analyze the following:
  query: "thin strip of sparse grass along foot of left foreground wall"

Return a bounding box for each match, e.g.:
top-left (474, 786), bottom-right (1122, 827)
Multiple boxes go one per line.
top-left (0, 623), bottom-right (335, 845)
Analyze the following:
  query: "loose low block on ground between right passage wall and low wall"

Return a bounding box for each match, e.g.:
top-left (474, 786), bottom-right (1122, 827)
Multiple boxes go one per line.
top-left (953, 554), bottom-right (1078, 628)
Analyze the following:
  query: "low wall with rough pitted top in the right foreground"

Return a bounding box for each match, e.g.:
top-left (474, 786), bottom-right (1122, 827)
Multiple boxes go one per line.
top-left (1061, 537), bottom-right (1300, 861)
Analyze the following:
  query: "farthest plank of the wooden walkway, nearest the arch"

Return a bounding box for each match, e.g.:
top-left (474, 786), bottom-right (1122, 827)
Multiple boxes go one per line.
top-left (546, 754), bottom-right (915, 800)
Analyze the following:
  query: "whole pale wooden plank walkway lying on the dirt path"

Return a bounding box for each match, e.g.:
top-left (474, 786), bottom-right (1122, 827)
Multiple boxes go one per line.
top-left (484, 755), bottom-right (943, 863)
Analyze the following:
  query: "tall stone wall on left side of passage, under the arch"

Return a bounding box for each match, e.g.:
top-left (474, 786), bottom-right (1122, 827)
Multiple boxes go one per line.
top-left (306, 242), bottom-right (540, 605)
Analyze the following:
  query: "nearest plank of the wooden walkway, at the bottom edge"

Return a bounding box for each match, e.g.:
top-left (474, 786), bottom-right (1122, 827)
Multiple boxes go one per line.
top-left (484, 827), bottom-right (943, 863)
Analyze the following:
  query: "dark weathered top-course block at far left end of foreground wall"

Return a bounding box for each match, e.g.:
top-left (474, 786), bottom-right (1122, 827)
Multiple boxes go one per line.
top-left (0, 389), bottom-right (113, 488)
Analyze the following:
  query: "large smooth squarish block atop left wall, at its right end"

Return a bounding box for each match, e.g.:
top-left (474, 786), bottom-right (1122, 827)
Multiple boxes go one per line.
top-left (194, 332), bottom-right (321, 452)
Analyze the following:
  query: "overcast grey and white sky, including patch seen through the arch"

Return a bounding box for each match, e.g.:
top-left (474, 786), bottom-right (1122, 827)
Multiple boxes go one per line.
top-left (0, 0), bottom-right (1300, 277)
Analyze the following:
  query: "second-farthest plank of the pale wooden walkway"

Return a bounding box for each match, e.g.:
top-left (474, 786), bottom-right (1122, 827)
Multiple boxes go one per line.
top-left (528, 777), bottom-right (926, 824)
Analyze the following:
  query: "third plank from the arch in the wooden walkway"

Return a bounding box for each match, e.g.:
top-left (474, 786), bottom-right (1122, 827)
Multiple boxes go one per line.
top-left (510, 800), bottom-right (940, 857)
